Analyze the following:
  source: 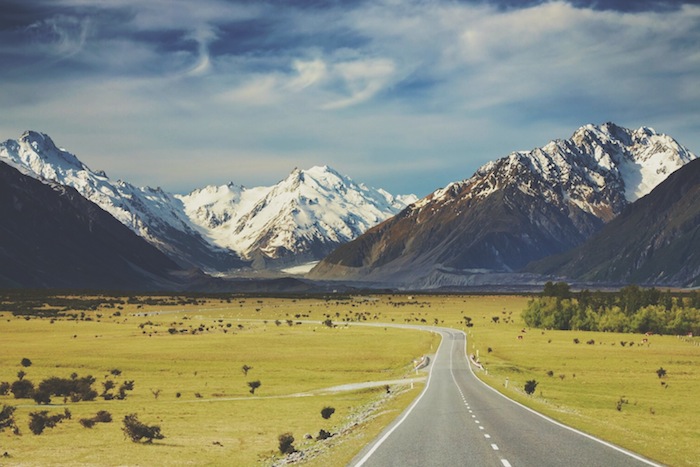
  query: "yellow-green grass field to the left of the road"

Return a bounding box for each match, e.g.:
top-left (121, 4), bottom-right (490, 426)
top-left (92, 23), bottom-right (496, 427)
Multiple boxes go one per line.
top-left (0, 299), bottom-right (437, 465)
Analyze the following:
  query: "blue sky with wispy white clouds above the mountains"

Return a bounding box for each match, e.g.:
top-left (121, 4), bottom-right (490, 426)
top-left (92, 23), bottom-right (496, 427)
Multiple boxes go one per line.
top-left (0, 0), bottom-right (700, 196)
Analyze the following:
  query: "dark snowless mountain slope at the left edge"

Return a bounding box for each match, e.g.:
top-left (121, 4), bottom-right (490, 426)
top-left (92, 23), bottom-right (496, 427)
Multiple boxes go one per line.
top-left (0, 163), bottom-right (182, 290)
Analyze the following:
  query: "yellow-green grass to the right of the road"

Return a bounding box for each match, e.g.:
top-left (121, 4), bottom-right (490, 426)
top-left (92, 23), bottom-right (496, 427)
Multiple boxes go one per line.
top-left (469, 310), bottom-right (700, 466)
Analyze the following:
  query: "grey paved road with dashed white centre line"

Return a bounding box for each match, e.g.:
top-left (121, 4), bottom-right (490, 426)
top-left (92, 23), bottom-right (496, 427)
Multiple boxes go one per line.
top-left (350, 327), bottom-right (658, 467)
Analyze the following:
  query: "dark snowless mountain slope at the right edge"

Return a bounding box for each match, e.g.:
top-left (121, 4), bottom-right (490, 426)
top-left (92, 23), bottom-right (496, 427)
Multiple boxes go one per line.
top-left (526, 160), bottom-right (700, 287)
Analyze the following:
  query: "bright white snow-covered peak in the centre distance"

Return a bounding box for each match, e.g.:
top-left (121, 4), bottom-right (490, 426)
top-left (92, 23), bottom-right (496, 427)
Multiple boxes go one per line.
top-left (178, 166), bottom-right (416, 266)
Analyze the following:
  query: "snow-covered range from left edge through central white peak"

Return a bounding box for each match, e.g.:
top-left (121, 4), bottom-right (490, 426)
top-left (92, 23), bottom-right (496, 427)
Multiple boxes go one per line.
top-left (0, 131), bottom-right (415, 272)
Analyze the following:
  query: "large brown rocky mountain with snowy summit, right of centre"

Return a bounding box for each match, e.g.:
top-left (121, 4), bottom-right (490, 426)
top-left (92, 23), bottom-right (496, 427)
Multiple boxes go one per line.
top-left (310, 123), bottom-right (696, 287)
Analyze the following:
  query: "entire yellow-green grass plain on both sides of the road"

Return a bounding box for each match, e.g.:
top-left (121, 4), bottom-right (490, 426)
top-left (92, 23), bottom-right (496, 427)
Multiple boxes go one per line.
top-left (0, 295), bottom-right (700, 466)
